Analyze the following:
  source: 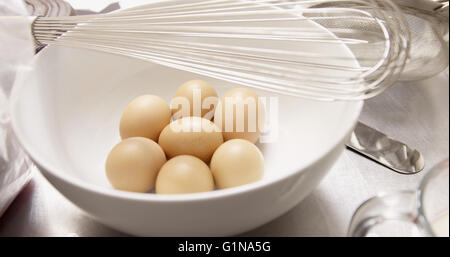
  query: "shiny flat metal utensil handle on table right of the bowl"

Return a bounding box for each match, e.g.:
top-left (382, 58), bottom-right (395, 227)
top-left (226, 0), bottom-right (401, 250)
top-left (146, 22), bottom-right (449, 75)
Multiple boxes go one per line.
top-left (347, 122), bottom-right (425, 174)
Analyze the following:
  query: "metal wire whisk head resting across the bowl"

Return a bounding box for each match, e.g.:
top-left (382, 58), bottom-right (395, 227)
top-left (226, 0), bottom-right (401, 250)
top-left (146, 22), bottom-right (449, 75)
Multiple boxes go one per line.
top-left (33, 0), bottom-right (409, 100)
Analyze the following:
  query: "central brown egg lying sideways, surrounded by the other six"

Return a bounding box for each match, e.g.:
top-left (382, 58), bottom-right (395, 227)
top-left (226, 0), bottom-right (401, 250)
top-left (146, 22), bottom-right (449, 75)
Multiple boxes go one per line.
top-left (158, 117), bottom-right (223, 163)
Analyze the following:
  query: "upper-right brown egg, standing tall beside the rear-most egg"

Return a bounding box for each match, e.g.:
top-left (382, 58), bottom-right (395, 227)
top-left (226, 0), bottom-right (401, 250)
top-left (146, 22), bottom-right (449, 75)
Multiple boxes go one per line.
top-left (214, 88), bottom-right (265, 143)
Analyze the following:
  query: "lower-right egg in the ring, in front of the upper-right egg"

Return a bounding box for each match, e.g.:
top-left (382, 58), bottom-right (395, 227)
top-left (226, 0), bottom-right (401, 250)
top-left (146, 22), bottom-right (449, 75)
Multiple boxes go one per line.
top-left (210, 139), bottom-right (264, 189)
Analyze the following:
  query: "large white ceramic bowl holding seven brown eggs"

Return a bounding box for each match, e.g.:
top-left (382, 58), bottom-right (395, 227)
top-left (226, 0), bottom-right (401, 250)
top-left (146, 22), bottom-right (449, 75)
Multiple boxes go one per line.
top-left (11, 16), bottom-right (363, 236)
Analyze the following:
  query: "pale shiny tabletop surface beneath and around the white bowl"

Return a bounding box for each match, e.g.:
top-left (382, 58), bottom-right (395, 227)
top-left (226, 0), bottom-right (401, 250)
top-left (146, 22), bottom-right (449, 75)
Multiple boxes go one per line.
top-left (0, 0), bottom-right (449, 236)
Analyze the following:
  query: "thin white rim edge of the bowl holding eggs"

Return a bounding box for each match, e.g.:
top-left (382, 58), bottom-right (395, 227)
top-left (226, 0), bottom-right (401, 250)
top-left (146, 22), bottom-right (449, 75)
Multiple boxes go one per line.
top-left (10, 46), bottom-right (364, 202)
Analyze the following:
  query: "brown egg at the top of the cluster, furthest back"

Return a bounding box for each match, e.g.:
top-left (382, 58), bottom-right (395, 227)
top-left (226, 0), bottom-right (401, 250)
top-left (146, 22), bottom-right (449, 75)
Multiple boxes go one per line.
top-left (171, 80), bottom-right (218, 120)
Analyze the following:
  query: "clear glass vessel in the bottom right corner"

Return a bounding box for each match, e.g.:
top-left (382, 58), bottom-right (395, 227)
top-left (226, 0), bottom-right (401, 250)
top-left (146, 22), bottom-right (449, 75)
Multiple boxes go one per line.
top-left (348, 159), bottom-right (449, 237)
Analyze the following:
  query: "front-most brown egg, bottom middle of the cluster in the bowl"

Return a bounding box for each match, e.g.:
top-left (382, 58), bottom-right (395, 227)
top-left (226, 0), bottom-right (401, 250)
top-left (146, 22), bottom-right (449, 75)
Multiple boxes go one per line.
top-left (156, 155), bottom-right (214, 194)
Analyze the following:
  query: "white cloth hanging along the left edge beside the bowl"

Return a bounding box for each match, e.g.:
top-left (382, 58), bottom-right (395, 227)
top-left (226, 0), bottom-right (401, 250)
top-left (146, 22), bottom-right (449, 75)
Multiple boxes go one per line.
top-left (0, 0), bottom-right (34, 216)
